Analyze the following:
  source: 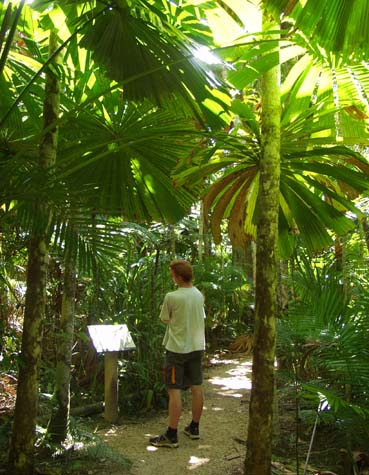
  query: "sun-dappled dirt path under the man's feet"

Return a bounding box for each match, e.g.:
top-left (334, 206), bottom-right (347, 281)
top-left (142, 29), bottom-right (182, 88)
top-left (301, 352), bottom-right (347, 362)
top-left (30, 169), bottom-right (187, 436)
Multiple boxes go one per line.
top-left (100, 357), bottom-right (251, 475)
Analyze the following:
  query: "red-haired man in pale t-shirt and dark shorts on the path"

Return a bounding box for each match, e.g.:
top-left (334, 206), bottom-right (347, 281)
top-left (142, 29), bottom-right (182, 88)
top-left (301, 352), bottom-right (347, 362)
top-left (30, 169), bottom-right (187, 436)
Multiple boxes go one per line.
top-left (150, 260), bottom-right (205, 448)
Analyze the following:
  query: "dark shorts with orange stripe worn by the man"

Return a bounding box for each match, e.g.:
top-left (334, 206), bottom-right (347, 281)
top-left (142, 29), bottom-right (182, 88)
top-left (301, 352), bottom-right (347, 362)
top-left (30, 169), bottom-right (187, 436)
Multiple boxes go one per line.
top-left (164, 351), bottom-right (203, 389)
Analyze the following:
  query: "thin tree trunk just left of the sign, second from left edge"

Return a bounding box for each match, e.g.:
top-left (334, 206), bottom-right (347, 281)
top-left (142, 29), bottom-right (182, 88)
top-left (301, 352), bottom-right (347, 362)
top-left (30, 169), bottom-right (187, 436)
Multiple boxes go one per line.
top-left (48, 244), bottom-right (76, 443)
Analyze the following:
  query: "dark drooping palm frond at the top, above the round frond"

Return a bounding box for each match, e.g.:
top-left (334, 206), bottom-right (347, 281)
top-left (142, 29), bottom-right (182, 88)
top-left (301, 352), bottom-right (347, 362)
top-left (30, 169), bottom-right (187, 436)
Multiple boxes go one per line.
top-left (76, 1), bottom-right (227, 124)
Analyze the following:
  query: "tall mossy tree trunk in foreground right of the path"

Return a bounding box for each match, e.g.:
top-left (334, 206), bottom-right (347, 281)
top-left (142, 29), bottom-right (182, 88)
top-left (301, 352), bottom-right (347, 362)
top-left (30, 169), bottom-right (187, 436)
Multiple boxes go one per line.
top-left (245, 7), bottom-right (280, 475)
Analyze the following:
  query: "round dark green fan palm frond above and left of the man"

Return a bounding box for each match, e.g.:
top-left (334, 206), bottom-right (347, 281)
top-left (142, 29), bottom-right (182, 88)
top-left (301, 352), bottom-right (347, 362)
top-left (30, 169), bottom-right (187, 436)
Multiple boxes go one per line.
top-left (56, 100), bottom-right (199, 221)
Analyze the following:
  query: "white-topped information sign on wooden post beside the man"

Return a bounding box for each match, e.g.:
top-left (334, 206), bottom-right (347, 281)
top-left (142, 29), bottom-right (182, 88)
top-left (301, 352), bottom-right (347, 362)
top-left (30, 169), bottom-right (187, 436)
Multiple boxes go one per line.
top-left (88, 325), bottom-right (136, 423)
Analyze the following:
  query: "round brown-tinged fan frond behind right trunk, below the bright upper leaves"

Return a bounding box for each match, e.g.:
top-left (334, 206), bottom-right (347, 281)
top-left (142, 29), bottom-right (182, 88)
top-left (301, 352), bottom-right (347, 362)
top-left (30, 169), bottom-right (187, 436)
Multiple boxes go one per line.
top-left (176, 114), bottom-right (369, 255)
